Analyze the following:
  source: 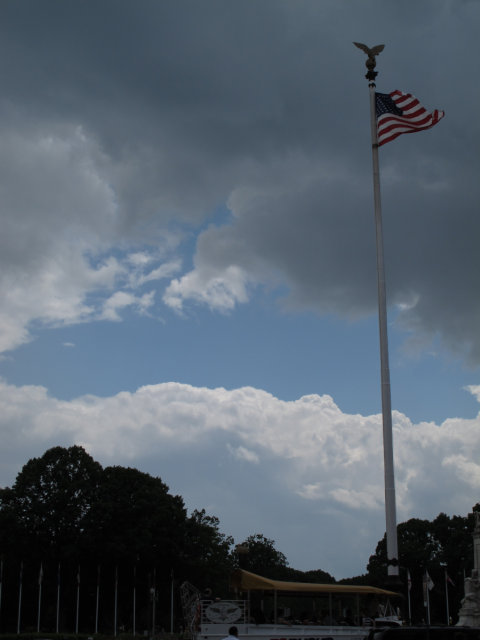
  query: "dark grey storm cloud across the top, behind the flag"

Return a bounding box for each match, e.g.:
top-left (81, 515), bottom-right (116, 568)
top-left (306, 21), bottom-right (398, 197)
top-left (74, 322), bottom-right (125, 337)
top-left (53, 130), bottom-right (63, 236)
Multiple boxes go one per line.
top-left (0, 0), bottom-right (480, 362)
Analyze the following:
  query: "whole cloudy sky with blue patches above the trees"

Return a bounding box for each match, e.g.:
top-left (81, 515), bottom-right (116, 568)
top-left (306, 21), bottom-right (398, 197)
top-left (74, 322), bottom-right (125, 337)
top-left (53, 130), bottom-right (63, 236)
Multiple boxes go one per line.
top-left (0, 0), bottom-right (480, 579)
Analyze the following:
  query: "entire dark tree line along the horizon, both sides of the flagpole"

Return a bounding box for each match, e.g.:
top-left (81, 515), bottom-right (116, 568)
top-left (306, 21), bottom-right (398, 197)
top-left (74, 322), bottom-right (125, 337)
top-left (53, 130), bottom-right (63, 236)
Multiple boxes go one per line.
top-left (0, 446), bottom-right (480, 635)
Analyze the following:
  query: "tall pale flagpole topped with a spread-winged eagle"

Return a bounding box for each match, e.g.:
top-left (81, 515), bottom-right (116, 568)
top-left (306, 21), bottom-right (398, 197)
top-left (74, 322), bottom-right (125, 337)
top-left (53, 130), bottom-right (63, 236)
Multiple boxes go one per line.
top-left (354, 42), bottom-right (399, 579)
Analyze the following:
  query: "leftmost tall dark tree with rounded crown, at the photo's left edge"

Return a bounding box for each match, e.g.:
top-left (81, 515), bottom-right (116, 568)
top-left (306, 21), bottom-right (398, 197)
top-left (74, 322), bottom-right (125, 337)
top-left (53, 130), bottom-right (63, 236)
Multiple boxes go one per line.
top-left (0, 446), bottom-right (103, 627)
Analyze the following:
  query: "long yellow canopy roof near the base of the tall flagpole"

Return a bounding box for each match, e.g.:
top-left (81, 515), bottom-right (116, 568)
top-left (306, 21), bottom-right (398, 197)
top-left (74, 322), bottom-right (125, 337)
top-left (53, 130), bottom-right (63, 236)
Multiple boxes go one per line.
top-left (230, 569), bottom-right (399, 596)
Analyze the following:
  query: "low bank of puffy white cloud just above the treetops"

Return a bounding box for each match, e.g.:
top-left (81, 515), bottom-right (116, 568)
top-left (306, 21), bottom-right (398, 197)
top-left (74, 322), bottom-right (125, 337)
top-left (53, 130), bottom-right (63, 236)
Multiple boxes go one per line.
top-left (0, 382), bottom-right (480, 573)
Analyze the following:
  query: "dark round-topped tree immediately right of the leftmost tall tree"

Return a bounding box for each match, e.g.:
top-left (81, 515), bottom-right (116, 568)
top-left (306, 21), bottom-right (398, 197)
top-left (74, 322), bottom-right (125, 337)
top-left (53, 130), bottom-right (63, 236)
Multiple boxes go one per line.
top-left (82, 466), bottom-right (186, 628)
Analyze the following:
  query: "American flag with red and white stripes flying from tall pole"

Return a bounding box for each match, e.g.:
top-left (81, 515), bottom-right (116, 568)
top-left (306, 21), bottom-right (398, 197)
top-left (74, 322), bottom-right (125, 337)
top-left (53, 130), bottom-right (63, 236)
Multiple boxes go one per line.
top-left (375, 90), bottom-right (445, 147)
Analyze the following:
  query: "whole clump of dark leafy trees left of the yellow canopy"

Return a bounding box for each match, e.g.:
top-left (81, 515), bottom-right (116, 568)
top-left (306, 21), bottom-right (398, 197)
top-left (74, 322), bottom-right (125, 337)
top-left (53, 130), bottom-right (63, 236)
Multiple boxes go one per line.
top-left (0, 446), bottom-right (233, 633)
